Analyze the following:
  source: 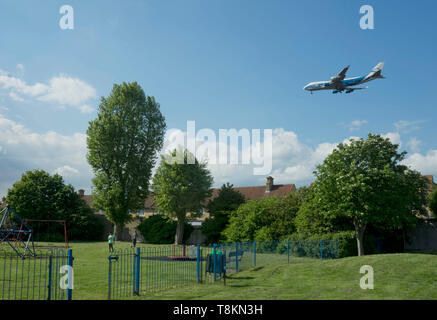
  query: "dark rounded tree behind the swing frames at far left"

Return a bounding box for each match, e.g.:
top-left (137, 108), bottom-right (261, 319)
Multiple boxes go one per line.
top-left (7, 170), bottom-right (103, 241)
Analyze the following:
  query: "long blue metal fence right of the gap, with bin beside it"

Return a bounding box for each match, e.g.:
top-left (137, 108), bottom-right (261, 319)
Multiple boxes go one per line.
top-left (108, 240), bottom-right (339, 299)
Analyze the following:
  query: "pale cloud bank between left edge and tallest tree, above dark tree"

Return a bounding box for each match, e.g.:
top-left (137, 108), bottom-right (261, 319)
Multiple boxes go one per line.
top-left (0, 114), bottom-right (92, 194)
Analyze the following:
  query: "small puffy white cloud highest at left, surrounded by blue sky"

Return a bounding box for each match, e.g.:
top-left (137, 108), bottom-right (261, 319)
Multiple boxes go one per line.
top-left (0, 70), bottom-right (97, 113)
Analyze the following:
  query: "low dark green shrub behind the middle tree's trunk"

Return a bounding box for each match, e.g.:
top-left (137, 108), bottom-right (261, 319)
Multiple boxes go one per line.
top-left (137, 214), bottom-right (194, 244)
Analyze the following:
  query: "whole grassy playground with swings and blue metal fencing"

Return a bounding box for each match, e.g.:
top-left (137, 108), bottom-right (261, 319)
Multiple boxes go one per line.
top-left (0, 207), bottom-right (437, 300)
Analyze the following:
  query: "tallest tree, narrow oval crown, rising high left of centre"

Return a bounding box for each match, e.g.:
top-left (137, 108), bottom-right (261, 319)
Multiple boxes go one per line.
top-left (87, 82), bottom-right (166, 239)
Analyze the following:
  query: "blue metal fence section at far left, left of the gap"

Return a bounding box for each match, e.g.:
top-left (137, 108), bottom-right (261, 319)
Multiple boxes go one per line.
top-left (0, 249), bottom-right (73, 300)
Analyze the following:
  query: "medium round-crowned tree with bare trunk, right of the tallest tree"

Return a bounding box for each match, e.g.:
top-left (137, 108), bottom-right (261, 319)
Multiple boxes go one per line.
top-left (152, 149), bottom-right (213, 244)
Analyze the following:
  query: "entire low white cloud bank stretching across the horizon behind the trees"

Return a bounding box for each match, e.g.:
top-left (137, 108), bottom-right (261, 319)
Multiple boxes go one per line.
top-left (0, 114), bottom-right (437, 198)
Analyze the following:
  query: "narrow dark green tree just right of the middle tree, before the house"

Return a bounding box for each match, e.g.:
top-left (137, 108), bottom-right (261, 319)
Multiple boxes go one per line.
top-left (201, 183), bottom-right (246, 243)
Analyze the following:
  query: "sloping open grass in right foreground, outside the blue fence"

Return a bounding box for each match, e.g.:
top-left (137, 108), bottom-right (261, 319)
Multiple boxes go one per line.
top-left (137, 254), bottom-right (437, 300)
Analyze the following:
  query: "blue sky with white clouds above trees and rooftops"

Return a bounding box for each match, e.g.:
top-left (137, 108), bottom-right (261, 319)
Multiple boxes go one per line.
top-left (0, 0), bottom-right (437, 194)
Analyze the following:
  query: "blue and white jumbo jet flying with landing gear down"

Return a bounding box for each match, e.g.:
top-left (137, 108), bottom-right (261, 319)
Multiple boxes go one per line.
top-left (303, 62), bottom-right (385, 94)
